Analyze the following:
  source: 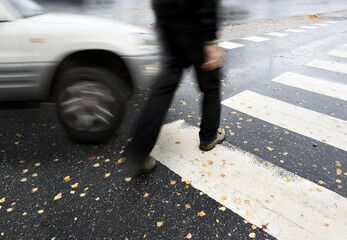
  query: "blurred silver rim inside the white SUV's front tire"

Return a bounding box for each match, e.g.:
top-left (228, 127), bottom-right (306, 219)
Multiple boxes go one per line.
top-left (59, 81), bottom-right (118, 132)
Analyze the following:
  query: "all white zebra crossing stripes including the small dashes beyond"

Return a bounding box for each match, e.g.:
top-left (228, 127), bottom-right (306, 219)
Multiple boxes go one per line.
top-left (152, 22), bottom-right (347, 240)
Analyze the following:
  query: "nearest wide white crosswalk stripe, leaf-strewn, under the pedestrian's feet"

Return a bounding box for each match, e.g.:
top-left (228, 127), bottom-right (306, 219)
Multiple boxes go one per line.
top-left (152, 121), bottom-right (347, 240)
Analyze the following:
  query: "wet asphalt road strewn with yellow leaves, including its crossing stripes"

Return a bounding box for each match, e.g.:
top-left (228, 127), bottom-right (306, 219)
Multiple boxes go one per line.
top-left (0, 1), bottom-right (347, 239)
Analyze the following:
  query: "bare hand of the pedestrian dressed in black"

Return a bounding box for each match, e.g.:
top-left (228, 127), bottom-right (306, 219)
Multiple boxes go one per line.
top-left (202, 44), bottom-right (223, 71)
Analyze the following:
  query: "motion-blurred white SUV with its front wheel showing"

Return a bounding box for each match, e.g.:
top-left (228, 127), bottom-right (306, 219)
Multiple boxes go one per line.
top-left (0, 0), bottom-right (159, 142)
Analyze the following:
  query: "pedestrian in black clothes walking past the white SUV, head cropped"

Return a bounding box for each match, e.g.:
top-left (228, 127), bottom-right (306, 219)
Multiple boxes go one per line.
top-left (126, 0), bottom-right (225, 172)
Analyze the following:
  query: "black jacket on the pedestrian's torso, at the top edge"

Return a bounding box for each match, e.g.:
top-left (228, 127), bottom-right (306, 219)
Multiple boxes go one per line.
top-left (152, 0), bottom-right (219, 41)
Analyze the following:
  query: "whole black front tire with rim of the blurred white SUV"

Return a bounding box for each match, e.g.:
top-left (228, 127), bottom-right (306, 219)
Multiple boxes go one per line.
top-left (55, 66), bottom-right (129, 143)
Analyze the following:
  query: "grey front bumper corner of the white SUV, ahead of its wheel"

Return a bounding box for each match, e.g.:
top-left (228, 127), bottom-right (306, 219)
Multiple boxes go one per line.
top-left (123, 54), bottom-right (161, 89)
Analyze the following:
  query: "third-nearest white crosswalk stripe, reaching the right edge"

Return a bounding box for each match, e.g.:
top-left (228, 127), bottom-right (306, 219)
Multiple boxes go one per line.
top-left (272, 72), bottom-right (347, 101)
